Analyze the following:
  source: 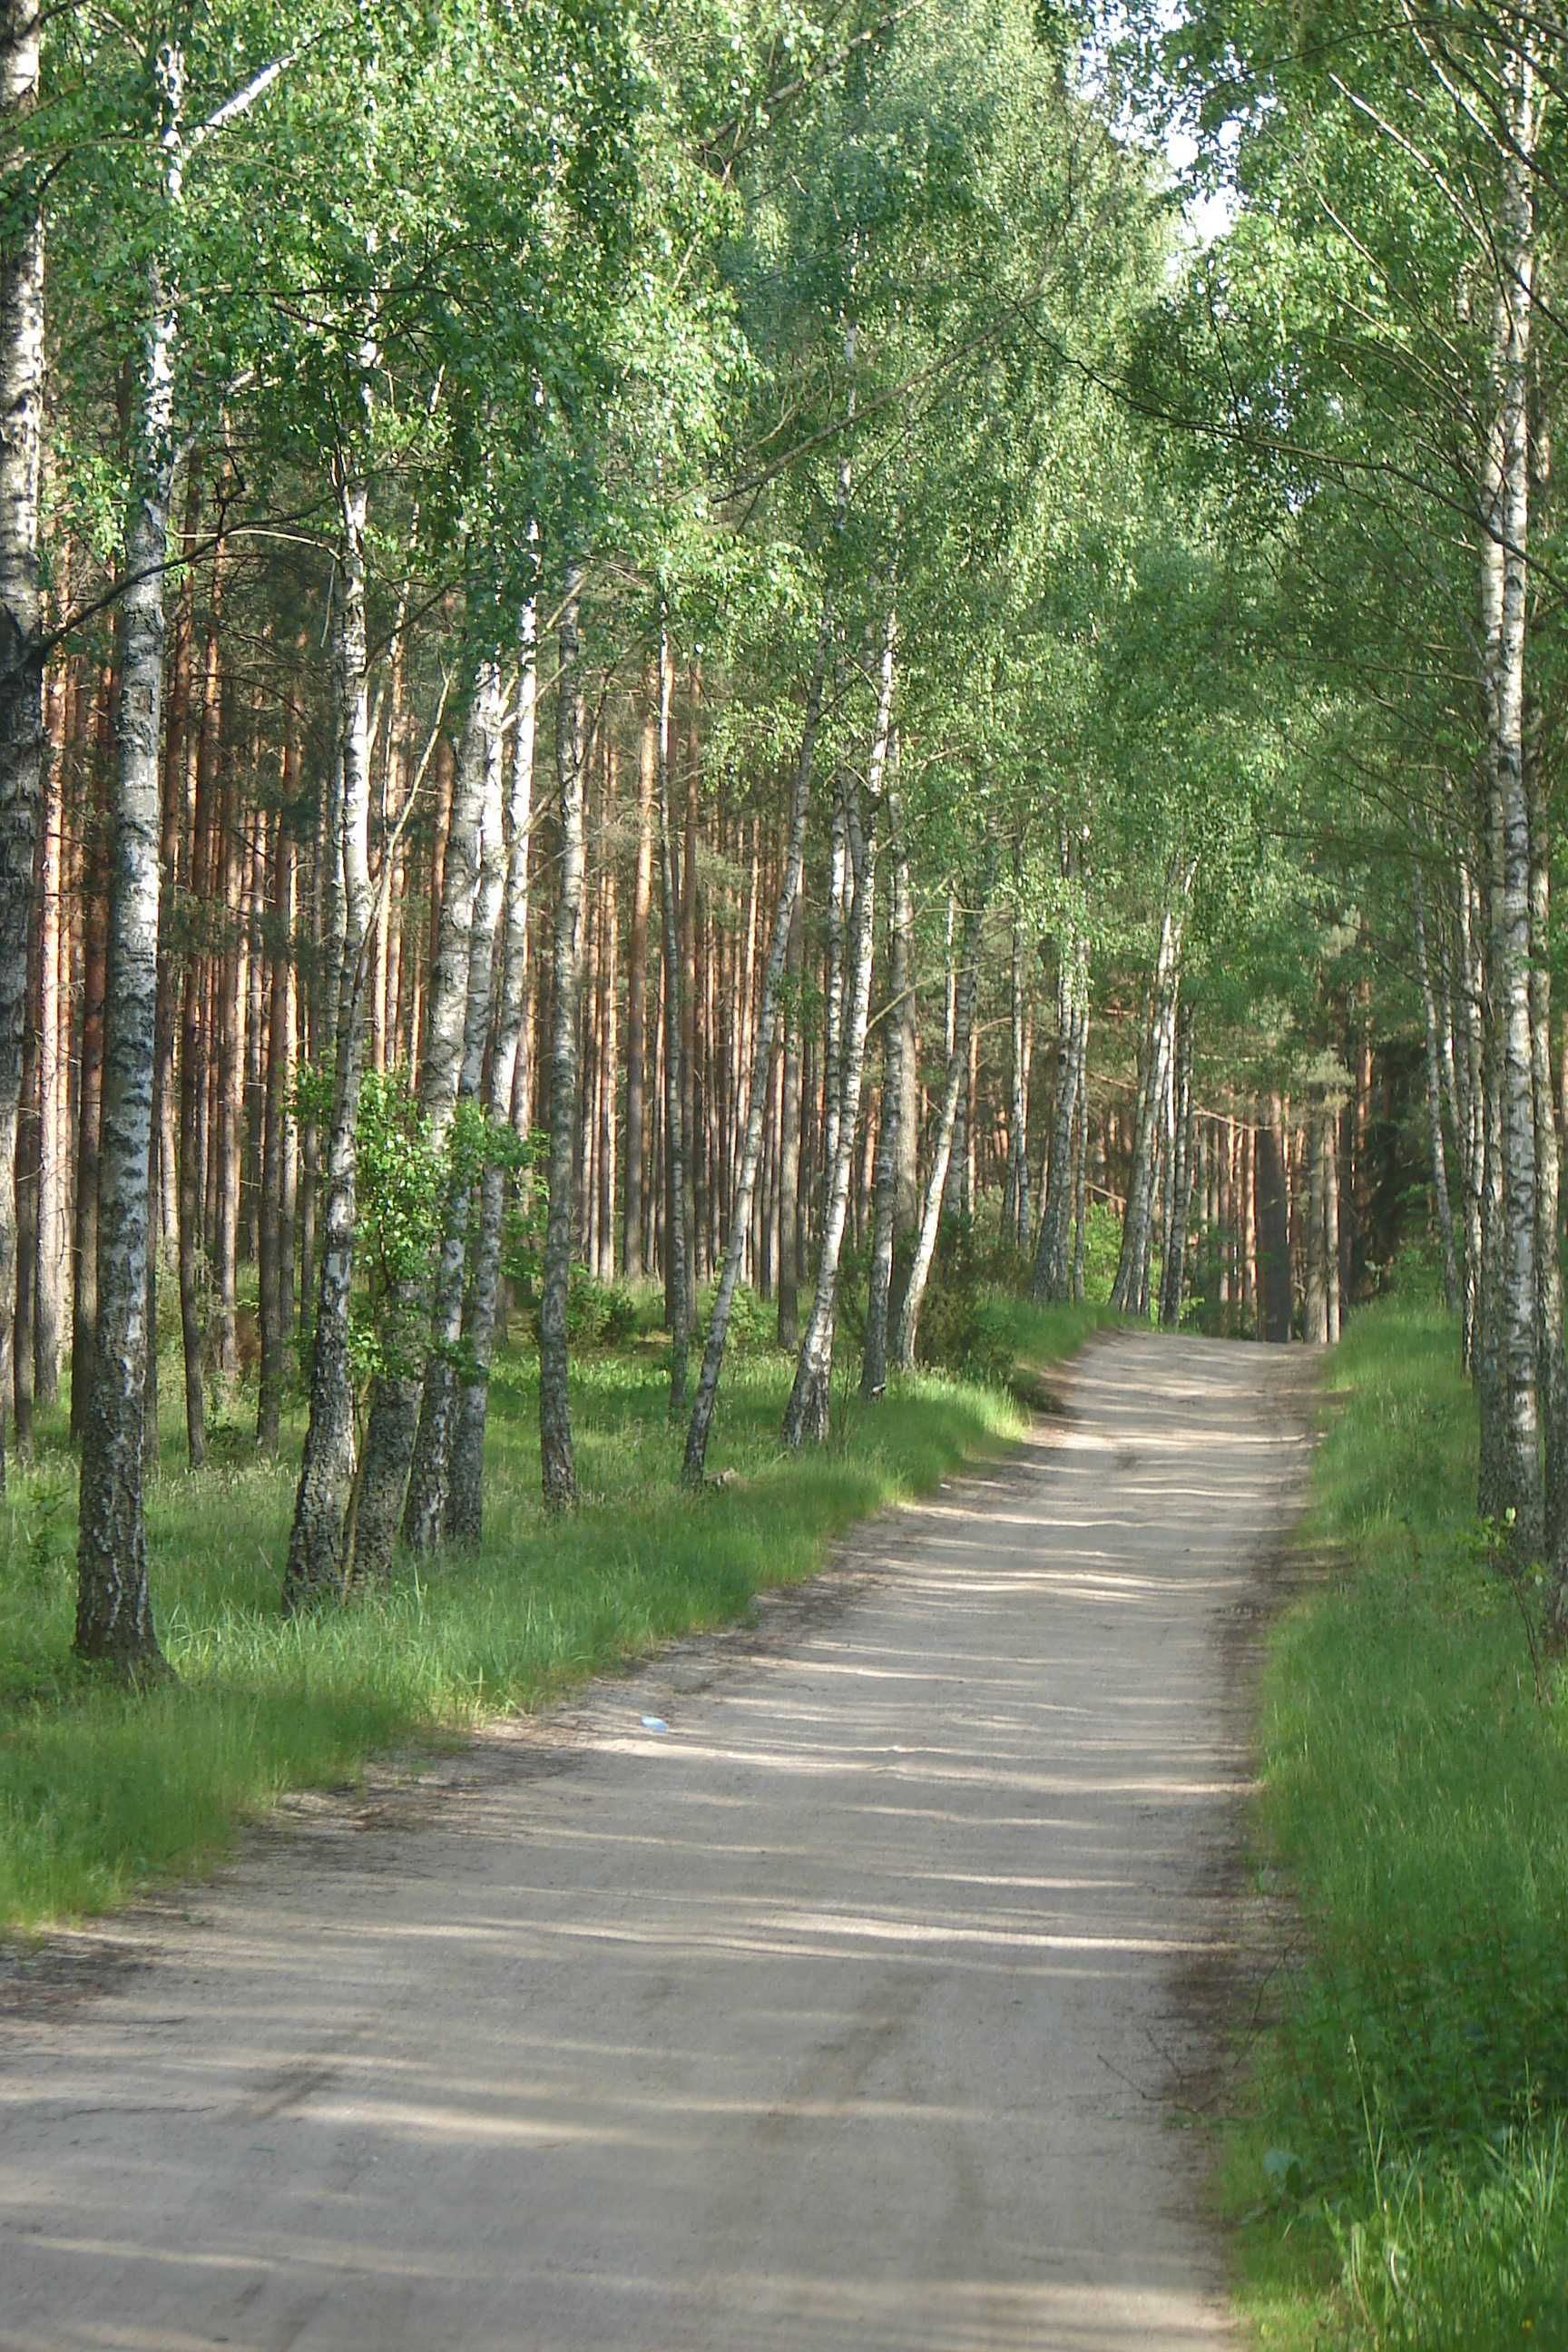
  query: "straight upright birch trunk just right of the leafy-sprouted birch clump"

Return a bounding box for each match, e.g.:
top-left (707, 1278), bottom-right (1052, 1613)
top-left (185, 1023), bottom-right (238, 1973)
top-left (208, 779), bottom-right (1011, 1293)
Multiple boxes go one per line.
top-left (538, 557), bottom-right (587, 1513)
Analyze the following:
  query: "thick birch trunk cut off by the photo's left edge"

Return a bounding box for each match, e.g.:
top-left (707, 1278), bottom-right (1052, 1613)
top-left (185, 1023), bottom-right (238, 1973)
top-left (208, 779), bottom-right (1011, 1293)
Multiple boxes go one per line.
top-left (0, 0), bottom-right (52, 1491)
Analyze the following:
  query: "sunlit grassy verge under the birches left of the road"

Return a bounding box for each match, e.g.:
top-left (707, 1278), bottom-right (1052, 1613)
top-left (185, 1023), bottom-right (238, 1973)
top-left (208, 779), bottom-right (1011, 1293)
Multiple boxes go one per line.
top-left (0, 1298), bottom-right (1105, 1934)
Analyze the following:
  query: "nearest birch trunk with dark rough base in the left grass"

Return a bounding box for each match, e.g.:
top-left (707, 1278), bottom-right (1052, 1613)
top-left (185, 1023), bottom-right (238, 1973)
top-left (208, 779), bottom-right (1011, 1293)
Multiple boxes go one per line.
top-left (75, 44), bottom-right (183, 1677)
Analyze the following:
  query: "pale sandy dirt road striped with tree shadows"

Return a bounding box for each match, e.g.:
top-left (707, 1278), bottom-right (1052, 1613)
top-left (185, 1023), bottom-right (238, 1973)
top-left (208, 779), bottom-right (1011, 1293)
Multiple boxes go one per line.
top-left (0, 1334), bottom-right (1312, 2352)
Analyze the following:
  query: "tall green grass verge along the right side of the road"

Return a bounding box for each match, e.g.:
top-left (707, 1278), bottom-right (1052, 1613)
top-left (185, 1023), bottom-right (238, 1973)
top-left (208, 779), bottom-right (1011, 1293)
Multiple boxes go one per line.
top-left (1227, 1300), bottom-right (1568, 2352)
